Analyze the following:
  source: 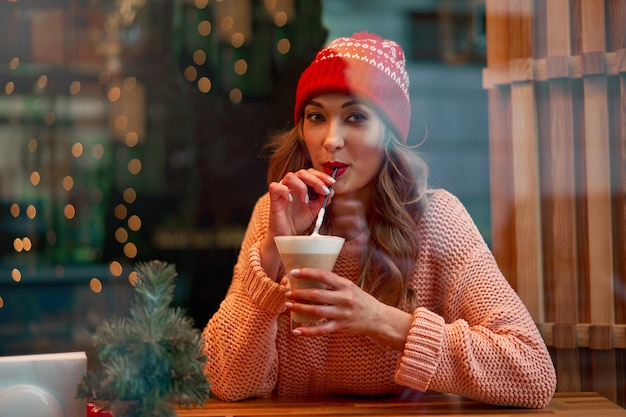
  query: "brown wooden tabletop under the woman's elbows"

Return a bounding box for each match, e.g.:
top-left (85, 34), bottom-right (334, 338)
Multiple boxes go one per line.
top-left (176, 392), bottom-right (626, 417)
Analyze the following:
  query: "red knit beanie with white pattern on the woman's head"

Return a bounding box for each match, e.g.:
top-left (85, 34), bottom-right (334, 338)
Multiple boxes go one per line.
top-left (294, 32), bottom-right (411, 143)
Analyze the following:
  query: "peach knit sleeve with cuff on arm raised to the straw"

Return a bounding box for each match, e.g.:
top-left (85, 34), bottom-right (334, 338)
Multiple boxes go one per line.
top-left (203, 196), bottom-right (286, 401)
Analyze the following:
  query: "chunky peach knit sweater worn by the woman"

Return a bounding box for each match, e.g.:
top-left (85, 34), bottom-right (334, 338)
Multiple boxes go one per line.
top-left (203, 190), bottom-right (556, 408)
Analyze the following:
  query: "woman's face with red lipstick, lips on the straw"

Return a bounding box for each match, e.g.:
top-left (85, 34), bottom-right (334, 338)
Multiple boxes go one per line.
top-left (303, 94), bottom-right (384, 197)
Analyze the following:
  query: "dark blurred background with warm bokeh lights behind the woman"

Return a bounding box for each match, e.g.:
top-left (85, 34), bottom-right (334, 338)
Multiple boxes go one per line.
top-left (0, 0), bottom-right (490, 355)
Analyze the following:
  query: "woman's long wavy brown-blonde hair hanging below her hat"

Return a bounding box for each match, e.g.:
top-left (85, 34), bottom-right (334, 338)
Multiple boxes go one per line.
top-left (266, 121), bottom-right (428, 312)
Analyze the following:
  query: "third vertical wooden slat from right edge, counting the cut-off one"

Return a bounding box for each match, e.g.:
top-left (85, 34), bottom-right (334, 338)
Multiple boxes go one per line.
top-left (544, 0), bottom-right (582, 391)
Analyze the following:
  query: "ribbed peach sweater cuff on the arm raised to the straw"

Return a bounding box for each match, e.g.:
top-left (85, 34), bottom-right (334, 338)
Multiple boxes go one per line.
top-left (242, 243), bottom-right (288, 315)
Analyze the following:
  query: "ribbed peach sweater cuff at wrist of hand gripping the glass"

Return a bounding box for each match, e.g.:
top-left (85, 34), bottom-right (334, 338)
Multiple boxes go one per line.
top-left (395, 307), bottom-right (445, 392)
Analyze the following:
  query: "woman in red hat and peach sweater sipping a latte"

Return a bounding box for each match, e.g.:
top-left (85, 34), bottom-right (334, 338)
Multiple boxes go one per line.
top-left (203, 32), bottom-right (556, 408)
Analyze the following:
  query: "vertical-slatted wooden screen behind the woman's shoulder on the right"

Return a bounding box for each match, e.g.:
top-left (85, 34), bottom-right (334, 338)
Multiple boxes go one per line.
top-left (483, 0), bottom-right (626, 405)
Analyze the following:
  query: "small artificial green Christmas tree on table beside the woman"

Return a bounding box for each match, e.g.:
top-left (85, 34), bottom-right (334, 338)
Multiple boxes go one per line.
top-left (76, 261), bottom-right (209, 417)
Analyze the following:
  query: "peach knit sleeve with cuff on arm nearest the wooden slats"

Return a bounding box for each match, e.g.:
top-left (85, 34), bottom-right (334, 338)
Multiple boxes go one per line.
top-left (395, 192), bottom-right (556, 408)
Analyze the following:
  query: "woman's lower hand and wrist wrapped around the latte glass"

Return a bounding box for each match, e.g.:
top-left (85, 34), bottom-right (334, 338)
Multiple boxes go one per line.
top-left (286, 268), bottom-right (413, 351)
